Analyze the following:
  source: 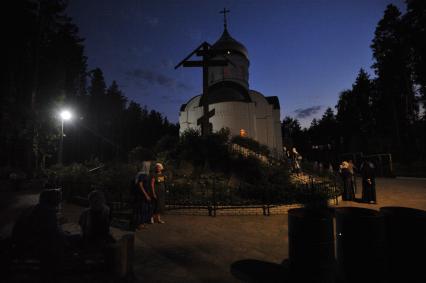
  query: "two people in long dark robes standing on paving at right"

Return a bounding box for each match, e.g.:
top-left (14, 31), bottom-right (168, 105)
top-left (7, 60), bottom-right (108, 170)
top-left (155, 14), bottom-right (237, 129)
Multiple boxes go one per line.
top-left (339, 159), bottom-right (376, 203)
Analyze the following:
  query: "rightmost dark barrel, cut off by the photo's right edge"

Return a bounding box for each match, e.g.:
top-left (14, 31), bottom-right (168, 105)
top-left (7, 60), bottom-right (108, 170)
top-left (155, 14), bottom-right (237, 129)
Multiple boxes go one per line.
top-left (380, 206), bottom-right (426, 282)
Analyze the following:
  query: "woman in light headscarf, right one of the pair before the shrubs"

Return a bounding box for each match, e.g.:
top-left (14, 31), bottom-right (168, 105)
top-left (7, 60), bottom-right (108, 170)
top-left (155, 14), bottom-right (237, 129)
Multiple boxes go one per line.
top-left (151, 163), bottom-right (166, 224)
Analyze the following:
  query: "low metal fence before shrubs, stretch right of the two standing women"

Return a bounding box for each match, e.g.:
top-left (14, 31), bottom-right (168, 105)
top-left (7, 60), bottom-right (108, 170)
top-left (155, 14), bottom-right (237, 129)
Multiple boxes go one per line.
top-left (166, 178), bottom-right (341, 216)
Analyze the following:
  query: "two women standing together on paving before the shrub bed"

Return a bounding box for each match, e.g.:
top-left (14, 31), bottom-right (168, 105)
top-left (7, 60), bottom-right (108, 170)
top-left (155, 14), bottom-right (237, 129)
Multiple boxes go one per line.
top-left (133, 161), bottom-right (166, 230)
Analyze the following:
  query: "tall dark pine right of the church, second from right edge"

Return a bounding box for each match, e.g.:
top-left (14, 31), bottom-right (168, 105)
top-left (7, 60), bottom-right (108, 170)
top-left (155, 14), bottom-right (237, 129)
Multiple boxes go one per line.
top-left (371, 5), bottom-right (417, 159)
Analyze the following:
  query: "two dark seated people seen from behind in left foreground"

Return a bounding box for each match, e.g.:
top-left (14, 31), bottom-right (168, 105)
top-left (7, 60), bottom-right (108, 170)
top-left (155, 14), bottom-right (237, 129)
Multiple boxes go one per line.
top-left (11, 189), bottom-right (115, 276)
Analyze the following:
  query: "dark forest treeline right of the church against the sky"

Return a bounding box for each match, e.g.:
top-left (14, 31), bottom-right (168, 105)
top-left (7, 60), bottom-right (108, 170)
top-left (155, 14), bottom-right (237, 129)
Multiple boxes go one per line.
top-left (282, 0), bottom-right (426, 162)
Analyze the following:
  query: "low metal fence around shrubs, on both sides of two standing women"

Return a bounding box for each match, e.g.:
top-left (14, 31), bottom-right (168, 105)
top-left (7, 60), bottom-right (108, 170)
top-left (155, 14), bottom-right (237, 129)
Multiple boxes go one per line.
top-left (61, 172), bottom-right (341, 219)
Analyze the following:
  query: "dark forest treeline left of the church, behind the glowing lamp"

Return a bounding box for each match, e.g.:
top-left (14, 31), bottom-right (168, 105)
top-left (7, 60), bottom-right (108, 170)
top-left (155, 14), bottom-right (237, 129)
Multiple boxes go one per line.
top-left (0, 0), bottom-right (178, 173)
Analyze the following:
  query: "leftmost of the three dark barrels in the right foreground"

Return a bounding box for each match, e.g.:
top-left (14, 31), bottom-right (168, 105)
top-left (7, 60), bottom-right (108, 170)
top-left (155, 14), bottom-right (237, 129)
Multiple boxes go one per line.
top-left (288, 208), bottom-right (335, 282)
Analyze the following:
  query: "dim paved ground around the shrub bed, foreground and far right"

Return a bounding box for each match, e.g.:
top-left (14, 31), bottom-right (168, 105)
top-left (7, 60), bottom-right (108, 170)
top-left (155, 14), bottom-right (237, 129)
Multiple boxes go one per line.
top-left (0, 178), bottom-right (426, 282)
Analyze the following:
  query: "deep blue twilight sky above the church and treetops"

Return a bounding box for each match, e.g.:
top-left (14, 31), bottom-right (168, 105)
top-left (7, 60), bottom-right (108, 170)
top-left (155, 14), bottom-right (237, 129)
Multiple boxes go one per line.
top-left (68, 0), bottom-right (405, 126)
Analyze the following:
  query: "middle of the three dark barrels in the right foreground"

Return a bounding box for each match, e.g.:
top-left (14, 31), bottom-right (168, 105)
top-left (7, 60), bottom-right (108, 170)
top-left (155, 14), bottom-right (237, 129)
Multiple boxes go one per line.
top-left (335, 207), bottom-right (387, 283)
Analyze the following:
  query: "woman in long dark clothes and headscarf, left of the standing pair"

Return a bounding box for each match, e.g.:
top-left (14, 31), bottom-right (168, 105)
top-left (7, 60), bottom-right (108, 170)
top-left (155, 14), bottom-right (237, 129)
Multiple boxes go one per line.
top-left (133, 161), bottom-right (154, 230)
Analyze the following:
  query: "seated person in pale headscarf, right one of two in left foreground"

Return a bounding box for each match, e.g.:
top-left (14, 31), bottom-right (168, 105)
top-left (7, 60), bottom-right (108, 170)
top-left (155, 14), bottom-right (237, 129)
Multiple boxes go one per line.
top-left (79, 190), bottom-right (114, 248)
